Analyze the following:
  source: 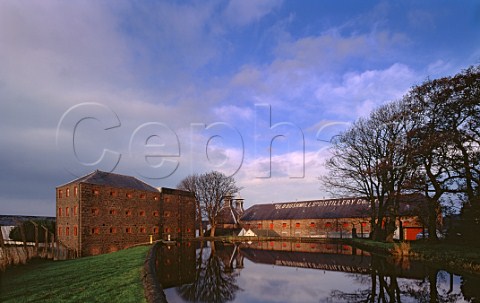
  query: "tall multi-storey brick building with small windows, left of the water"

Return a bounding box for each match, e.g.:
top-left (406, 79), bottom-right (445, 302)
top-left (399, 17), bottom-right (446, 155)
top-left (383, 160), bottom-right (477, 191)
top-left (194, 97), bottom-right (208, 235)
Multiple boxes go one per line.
top-left (56, 170), bottom-right (195, 256)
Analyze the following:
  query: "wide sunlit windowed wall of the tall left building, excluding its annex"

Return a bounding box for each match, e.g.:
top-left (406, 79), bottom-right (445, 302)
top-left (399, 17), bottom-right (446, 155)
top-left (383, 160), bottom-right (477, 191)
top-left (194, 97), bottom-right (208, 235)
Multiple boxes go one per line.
top-left (80, 183), bottom-right (161, 256)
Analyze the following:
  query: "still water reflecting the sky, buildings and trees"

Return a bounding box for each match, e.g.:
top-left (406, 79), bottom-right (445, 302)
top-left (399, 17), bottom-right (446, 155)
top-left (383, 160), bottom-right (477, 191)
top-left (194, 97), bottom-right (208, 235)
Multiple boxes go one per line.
top-left (157, 241), bottom-right (480, 303)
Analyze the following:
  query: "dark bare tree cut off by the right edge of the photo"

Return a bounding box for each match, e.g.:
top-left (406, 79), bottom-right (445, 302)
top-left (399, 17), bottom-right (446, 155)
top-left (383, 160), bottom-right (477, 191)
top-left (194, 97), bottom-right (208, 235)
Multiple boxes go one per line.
top-left (404, 67), bottom-right (480, 241)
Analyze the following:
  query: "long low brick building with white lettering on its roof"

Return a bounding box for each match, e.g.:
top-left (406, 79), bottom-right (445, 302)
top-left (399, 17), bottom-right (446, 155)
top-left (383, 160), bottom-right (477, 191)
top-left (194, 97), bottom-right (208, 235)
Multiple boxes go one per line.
top-left (240, 196), bottom-right (424, 240)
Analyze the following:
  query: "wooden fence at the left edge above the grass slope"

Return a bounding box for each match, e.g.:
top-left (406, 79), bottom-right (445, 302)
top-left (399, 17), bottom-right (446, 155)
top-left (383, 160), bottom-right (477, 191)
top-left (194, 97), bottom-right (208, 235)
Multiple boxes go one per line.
top-left (0, 221), bottom-right (77, 271)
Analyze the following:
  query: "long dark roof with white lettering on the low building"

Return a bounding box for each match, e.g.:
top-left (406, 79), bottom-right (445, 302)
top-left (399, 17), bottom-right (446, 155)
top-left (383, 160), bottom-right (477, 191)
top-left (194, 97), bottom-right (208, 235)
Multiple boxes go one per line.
top-left (240, 195), bottom-right (425, 221)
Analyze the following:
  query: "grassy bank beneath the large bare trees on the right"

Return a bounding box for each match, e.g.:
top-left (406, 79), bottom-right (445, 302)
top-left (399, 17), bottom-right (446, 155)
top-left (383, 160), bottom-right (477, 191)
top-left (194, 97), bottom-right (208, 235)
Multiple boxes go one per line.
top-left (348, 239), bottom-right (480, 275)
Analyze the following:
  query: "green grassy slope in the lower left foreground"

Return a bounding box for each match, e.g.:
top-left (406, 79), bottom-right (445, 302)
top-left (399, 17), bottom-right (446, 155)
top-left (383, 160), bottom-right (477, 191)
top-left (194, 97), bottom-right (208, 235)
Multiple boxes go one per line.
top-left (0, 246), bottom-right (149, 302)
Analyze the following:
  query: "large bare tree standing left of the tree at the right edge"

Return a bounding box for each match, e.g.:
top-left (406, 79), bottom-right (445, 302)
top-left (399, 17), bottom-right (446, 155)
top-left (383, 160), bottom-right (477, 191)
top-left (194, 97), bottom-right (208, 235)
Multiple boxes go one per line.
top-left (322, 102), bottom-right (414, 241)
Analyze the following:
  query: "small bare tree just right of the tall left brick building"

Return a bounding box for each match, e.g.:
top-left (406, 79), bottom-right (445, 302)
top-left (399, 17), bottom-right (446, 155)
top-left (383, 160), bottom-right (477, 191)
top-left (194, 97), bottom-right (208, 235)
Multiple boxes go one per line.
top-left (178, 171), bottom-right (241, 237)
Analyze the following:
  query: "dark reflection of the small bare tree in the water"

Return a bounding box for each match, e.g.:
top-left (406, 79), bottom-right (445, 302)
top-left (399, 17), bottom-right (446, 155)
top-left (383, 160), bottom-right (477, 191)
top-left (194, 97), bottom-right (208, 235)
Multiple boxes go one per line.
top-left (177, 242), bottom-right (240, 302)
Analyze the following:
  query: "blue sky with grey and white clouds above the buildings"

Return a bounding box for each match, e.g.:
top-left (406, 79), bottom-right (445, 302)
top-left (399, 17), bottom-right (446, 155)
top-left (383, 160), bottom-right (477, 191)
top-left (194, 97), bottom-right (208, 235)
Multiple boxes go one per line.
top-left (0, 0), bottom-right (480, 216)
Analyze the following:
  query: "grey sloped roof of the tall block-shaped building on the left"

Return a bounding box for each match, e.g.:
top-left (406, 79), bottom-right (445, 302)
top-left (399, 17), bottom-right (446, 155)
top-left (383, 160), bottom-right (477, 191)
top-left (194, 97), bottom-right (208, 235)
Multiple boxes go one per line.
top-left (61, 170), bottom-right (158, 192)
